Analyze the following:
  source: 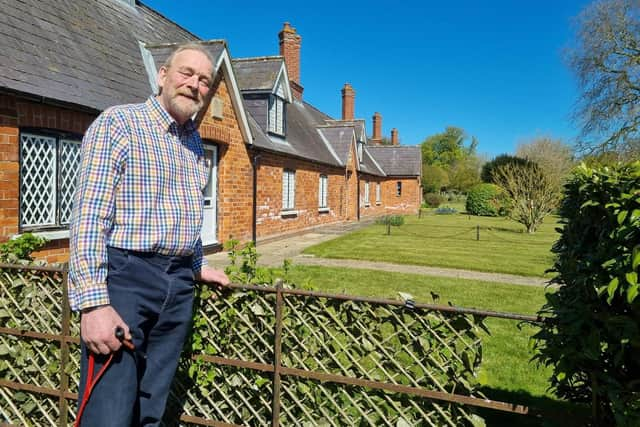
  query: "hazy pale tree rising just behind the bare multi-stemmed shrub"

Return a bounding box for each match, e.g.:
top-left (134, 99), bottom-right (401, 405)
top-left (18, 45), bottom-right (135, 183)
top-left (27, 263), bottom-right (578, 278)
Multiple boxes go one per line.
top-left (516, 136), bottom-right (575, 187)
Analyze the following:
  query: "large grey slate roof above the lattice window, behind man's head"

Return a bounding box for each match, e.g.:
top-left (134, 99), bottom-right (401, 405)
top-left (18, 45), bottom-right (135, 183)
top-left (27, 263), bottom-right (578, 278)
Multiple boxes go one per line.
top-left (0, 0), bottom-right (197, 111)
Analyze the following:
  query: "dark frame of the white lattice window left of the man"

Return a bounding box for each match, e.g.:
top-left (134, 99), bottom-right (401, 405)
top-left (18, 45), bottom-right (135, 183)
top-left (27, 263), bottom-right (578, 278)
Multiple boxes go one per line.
top-left (18, 127), bottom-right (82, 232)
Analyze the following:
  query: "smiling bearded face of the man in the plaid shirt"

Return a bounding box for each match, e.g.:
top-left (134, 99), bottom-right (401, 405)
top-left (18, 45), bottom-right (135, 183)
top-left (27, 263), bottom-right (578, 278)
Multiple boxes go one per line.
top-left (158, 50), bottom-right (213, 124)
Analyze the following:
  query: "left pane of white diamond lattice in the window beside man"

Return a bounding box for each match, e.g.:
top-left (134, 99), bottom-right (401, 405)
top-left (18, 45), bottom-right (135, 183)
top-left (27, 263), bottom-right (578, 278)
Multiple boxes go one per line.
top-left (20, 133), bottom-right (57, 226)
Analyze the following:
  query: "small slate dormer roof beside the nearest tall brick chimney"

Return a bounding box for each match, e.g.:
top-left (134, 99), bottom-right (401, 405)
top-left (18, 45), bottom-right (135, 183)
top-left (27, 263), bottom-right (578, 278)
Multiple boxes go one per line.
top-left (232, 56), bottom-right (284, 92)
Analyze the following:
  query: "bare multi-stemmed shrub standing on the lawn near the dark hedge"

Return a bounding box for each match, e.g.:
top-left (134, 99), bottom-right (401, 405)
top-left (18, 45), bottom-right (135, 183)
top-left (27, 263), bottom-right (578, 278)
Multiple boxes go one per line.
top-left (493, 163), bottom-right (560, 233)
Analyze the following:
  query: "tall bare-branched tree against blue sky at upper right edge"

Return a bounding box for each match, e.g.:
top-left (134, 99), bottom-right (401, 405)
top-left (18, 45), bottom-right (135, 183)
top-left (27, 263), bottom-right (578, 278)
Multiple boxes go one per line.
top-left (568, 0), bottom-right (640, 157)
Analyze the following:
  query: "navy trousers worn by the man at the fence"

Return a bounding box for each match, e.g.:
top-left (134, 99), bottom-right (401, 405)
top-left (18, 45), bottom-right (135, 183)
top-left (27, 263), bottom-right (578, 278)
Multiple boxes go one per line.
top-left (79, 248), bottom-right (193, 427)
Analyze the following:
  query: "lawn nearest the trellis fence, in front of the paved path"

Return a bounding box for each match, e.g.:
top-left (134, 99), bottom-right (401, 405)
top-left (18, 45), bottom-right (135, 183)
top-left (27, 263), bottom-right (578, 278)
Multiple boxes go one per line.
top-left (278, 265), bottom-right (582, 426)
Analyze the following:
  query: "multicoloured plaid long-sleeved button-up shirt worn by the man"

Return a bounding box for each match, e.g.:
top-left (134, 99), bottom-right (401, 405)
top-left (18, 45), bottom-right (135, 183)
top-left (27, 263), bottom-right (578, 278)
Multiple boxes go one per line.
top-left (69, 97), bottom-right (209, 310)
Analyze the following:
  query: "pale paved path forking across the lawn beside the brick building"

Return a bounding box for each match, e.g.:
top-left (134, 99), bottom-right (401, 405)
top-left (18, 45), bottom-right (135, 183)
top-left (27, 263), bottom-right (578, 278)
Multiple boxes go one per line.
top-left (202, 220), bottom-right (548, 286)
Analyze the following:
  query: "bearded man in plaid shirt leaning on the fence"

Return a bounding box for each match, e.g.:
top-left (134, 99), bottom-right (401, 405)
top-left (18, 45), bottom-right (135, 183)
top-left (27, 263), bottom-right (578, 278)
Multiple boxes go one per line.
top-left (69, 44), bottom-right (229, 427)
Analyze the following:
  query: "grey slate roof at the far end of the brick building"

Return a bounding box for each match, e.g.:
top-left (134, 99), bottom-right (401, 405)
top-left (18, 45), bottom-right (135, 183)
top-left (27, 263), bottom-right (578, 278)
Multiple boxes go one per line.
top-left (367, 145), bottom-right (422, 176)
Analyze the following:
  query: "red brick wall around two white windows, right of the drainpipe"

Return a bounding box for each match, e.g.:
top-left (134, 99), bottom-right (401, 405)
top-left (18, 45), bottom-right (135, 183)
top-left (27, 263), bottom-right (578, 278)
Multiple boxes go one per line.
top-left (256, 152), bottom-right (345, 238)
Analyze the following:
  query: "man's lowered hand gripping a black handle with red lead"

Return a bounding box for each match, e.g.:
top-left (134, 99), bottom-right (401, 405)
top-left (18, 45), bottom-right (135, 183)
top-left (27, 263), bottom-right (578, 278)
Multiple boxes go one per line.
top-left (80, 305), bottom-right (131, 354)
